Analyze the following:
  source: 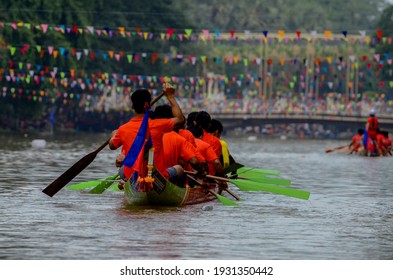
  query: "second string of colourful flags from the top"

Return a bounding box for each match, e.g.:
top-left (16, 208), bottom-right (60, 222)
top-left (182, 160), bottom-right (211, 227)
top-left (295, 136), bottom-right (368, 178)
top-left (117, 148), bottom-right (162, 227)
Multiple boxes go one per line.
top-left (0, 43), bottom-right (393, 67)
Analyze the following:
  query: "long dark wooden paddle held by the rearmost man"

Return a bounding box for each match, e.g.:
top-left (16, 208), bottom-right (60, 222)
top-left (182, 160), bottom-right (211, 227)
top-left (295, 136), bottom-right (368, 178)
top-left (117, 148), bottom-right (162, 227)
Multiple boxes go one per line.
top-left (42, 92), bottom-right (165, 197)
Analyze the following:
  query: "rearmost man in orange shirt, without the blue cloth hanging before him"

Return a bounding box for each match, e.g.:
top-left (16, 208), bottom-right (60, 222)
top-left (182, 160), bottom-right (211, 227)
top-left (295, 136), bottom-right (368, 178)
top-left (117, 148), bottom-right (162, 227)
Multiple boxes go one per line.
top-left (109, 83), bottom-right (184, 185)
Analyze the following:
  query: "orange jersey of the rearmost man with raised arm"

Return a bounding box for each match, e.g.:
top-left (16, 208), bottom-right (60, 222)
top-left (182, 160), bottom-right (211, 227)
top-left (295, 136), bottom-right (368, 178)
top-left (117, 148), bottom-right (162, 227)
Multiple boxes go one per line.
top-left (112, 118), bottom-right (175, 178)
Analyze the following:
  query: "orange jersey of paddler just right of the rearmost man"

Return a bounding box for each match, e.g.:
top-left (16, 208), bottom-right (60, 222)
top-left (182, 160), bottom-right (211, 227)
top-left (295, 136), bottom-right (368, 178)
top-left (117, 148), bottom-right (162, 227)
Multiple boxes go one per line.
top-left (162, 131), bottom-right (197, 168)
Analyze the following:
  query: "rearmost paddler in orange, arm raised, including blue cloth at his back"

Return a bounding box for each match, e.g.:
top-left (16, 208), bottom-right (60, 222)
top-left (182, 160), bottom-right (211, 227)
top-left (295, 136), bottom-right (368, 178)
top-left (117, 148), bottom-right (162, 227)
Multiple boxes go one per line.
top-left (109, 83), bottom-right (184, 187)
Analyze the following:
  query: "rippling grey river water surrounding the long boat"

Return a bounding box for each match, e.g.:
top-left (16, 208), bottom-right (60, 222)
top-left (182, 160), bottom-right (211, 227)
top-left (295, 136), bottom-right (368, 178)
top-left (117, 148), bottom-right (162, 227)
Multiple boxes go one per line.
top-left (0, 134), bottom-right (393, 259)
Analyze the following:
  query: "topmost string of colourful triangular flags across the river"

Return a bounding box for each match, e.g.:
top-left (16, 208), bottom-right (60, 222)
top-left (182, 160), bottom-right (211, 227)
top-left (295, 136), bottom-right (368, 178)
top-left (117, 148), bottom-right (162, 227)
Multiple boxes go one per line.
top-left (0, 21), bottom-right (392, 44)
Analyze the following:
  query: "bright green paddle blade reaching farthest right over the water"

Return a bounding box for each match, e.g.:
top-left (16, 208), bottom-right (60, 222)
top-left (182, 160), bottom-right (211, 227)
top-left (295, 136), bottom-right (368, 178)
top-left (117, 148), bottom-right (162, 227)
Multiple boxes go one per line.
top-left (230, 179), bottom-right (310, 200)
